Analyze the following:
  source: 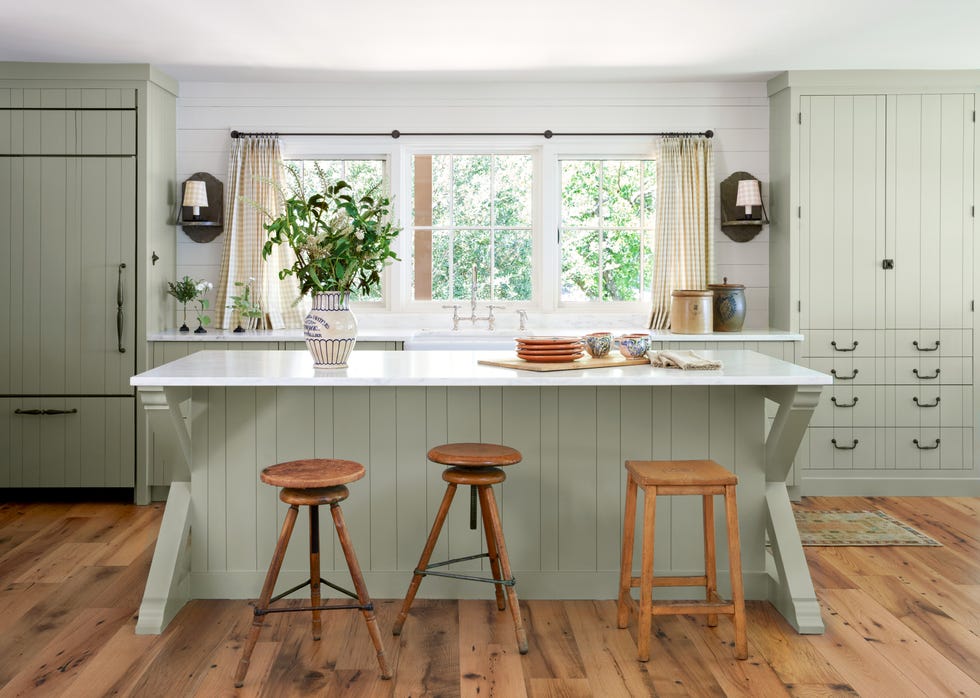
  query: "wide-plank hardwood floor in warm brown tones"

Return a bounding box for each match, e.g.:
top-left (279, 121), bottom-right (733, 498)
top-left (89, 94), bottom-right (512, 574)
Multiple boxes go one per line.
top-left (0, 497), bottom-right (980, 698)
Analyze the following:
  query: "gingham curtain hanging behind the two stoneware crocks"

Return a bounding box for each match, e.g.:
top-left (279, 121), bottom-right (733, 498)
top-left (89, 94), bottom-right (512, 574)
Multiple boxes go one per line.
top-left (650, 137), bottom-right (715, 329)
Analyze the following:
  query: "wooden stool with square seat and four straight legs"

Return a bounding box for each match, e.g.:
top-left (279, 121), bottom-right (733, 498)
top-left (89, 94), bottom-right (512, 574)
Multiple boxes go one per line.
top-left (617, 460), bottom-right (749, 662)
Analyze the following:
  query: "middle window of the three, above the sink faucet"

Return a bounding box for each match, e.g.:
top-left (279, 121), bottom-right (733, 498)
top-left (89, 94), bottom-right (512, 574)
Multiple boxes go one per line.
top-left (410, 153), bottom-right (534, 301)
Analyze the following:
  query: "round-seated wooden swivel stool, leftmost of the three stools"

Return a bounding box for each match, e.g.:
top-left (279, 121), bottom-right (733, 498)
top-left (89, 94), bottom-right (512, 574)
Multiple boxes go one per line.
top-left (235, 458), bottom-right (391, 688)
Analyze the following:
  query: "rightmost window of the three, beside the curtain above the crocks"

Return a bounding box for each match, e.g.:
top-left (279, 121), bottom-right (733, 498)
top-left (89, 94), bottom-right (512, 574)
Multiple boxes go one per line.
top-left (559, 159), bottom-right (656, 304)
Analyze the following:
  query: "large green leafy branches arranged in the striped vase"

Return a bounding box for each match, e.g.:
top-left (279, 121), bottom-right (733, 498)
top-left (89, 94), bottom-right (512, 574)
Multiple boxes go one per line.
top-left (262, 171), bottom-right (401, 295)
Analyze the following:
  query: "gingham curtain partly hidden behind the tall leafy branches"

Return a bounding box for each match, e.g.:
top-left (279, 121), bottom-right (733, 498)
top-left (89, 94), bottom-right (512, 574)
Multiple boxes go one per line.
top-left (215, 136), bottom-right (306, 329)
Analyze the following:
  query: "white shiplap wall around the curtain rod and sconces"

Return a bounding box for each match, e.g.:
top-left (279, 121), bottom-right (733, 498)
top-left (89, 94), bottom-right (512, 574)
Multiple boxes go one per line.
top-left (176, 82), bottom-right (769, 328)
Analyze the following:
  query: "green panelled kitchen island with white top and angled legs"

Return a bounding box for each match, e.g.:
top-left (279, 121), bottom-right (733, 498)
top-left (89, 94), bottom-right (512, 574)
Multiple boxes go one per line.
top-left (132, 350), bottom-right (831, 633)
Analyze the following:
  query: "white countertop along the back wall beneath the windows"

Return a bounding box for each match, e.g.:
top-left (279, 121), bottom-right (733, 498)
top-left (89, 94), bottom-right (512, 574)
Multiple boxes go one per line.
top-left (147, 327), bottom-right (803, 342)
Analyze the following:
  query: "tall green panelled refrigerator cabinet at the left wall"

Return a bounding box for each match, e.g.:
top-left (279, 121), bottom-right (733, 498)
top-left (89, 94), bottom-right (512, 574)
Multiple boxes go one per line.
top-left (0, 63), bottom-right (176, 500)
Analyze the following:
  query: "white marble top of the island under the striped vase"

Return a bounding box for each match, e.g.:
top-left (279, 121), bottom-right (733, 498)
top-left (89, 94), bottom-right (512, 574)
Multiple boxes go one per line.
top-left (130, 350), bottom-right (833, 387)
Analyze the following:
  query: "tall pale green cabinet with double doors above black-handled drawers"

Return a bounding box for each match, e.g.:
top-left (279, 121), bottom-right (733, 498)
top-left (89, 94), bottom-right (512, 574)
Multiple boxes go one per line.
top-left (769, 71), bottom-right (980, 495)
